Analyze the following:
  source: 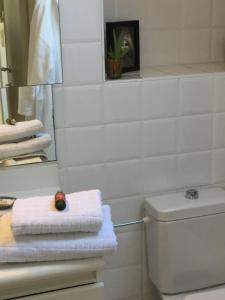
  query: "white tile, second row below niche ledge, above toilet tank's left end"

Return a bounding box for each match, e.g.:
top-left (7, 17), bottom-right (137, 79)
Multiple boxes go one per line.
top-left (142, 119), bottom-right (178, 156)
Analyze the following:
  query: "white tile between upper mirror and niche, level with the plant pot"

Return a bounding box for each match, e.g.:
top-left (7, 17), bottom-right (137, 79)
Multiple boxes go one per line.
top-left (62, 43), bottom-right (103, 85)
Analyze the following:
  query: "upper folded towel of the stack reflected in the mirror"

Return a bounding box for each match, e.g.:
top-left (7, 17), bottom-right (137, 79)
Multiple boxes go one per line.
top-left (0, 120), bottom-right (44, 143)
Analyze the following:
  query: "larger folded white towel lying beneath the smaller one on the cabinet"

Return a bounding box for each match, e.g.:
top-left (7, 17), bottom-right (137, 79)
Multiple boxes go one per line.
top-left (0, 205), bottom-right (117, 262)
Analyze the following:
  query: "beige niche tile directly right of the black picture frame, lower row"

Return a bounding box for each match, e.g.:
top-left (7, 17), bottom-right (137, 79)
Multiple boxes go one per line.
top-left (141, 30), bottom-right (180, 66)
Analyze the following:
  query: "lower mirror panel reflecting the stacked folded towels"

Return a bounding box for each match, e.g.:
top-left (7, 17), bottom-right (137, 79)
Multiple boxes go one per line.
top-left (0, 85), bottom-right (56, 167)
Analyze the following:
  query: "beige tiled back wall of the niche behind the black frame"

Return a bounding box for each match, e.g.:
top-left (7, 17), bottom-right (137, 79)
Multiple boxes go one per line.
top-left (104, 0), bottom-right (225, 67)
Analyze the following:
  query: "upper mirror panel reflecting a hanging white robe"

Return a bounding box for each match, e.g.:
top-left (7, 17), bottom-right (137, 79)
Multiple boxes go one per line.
top-left (0, 0), bottom-right (62, 87)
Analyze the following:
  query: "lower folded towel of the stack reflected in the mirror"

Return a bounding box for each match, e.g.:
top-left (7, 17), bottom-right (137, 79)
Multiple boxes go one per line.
top-left (0, 134), bottom-right (52, 160)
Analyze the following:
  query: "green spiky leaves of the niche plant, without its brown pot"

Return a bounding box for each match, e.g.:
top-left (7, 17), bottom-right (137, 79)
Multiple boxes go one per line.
top-left (108, 30), bottom-right (129, 60)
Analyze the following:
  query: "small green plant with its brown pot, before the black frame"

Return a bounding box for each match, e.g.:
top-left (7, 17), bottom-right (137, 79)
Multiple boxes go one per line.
top-left (106, 30), bottom-right (129, 79)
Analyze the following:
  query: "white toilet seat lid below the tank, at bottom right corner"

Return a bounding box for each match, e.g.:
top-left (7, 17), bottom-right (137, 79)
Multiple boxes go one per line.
top-left (161, 285), bottom-right (225, 300)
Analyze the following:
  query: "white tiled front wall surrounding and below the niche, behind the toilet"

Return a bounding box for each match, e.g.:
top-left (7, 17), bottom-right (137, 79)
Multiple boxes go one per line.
top-left (54, 0), bottom-right (225, 300)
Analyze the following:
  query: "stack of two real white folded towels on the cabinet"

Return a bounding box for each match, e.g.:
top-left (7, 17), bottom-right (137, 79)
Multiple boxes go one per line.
top-left (0, 190), bottom-right (117, 263)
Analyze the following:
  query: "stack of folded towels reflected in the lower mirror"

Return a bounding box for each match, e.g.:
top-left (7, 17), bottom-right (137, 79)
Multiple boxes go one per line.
top-left (0, 120), bottom-right (51, 161)
